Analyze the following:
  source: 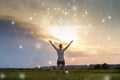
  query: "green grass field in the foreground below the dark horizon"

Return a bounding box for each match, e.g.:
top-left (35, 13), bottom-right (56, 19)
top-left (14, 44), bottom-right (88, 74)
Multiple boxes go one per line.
top-left (0, 70), bottom-right (120, 80)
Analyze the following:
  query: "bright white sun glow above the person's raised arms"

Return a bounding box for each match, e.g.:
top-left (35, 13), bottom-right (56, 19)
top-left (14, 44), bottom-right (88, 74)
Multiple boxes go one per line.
top-left (50, 26), bottom-right (78, 42)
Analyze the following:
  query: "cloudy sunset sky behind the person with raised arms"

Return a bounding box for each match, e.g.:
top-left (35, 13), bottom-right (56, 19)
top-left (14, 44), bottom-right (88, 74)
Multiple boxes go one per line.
top-left (0, 0), bottom-right (120, 68)
